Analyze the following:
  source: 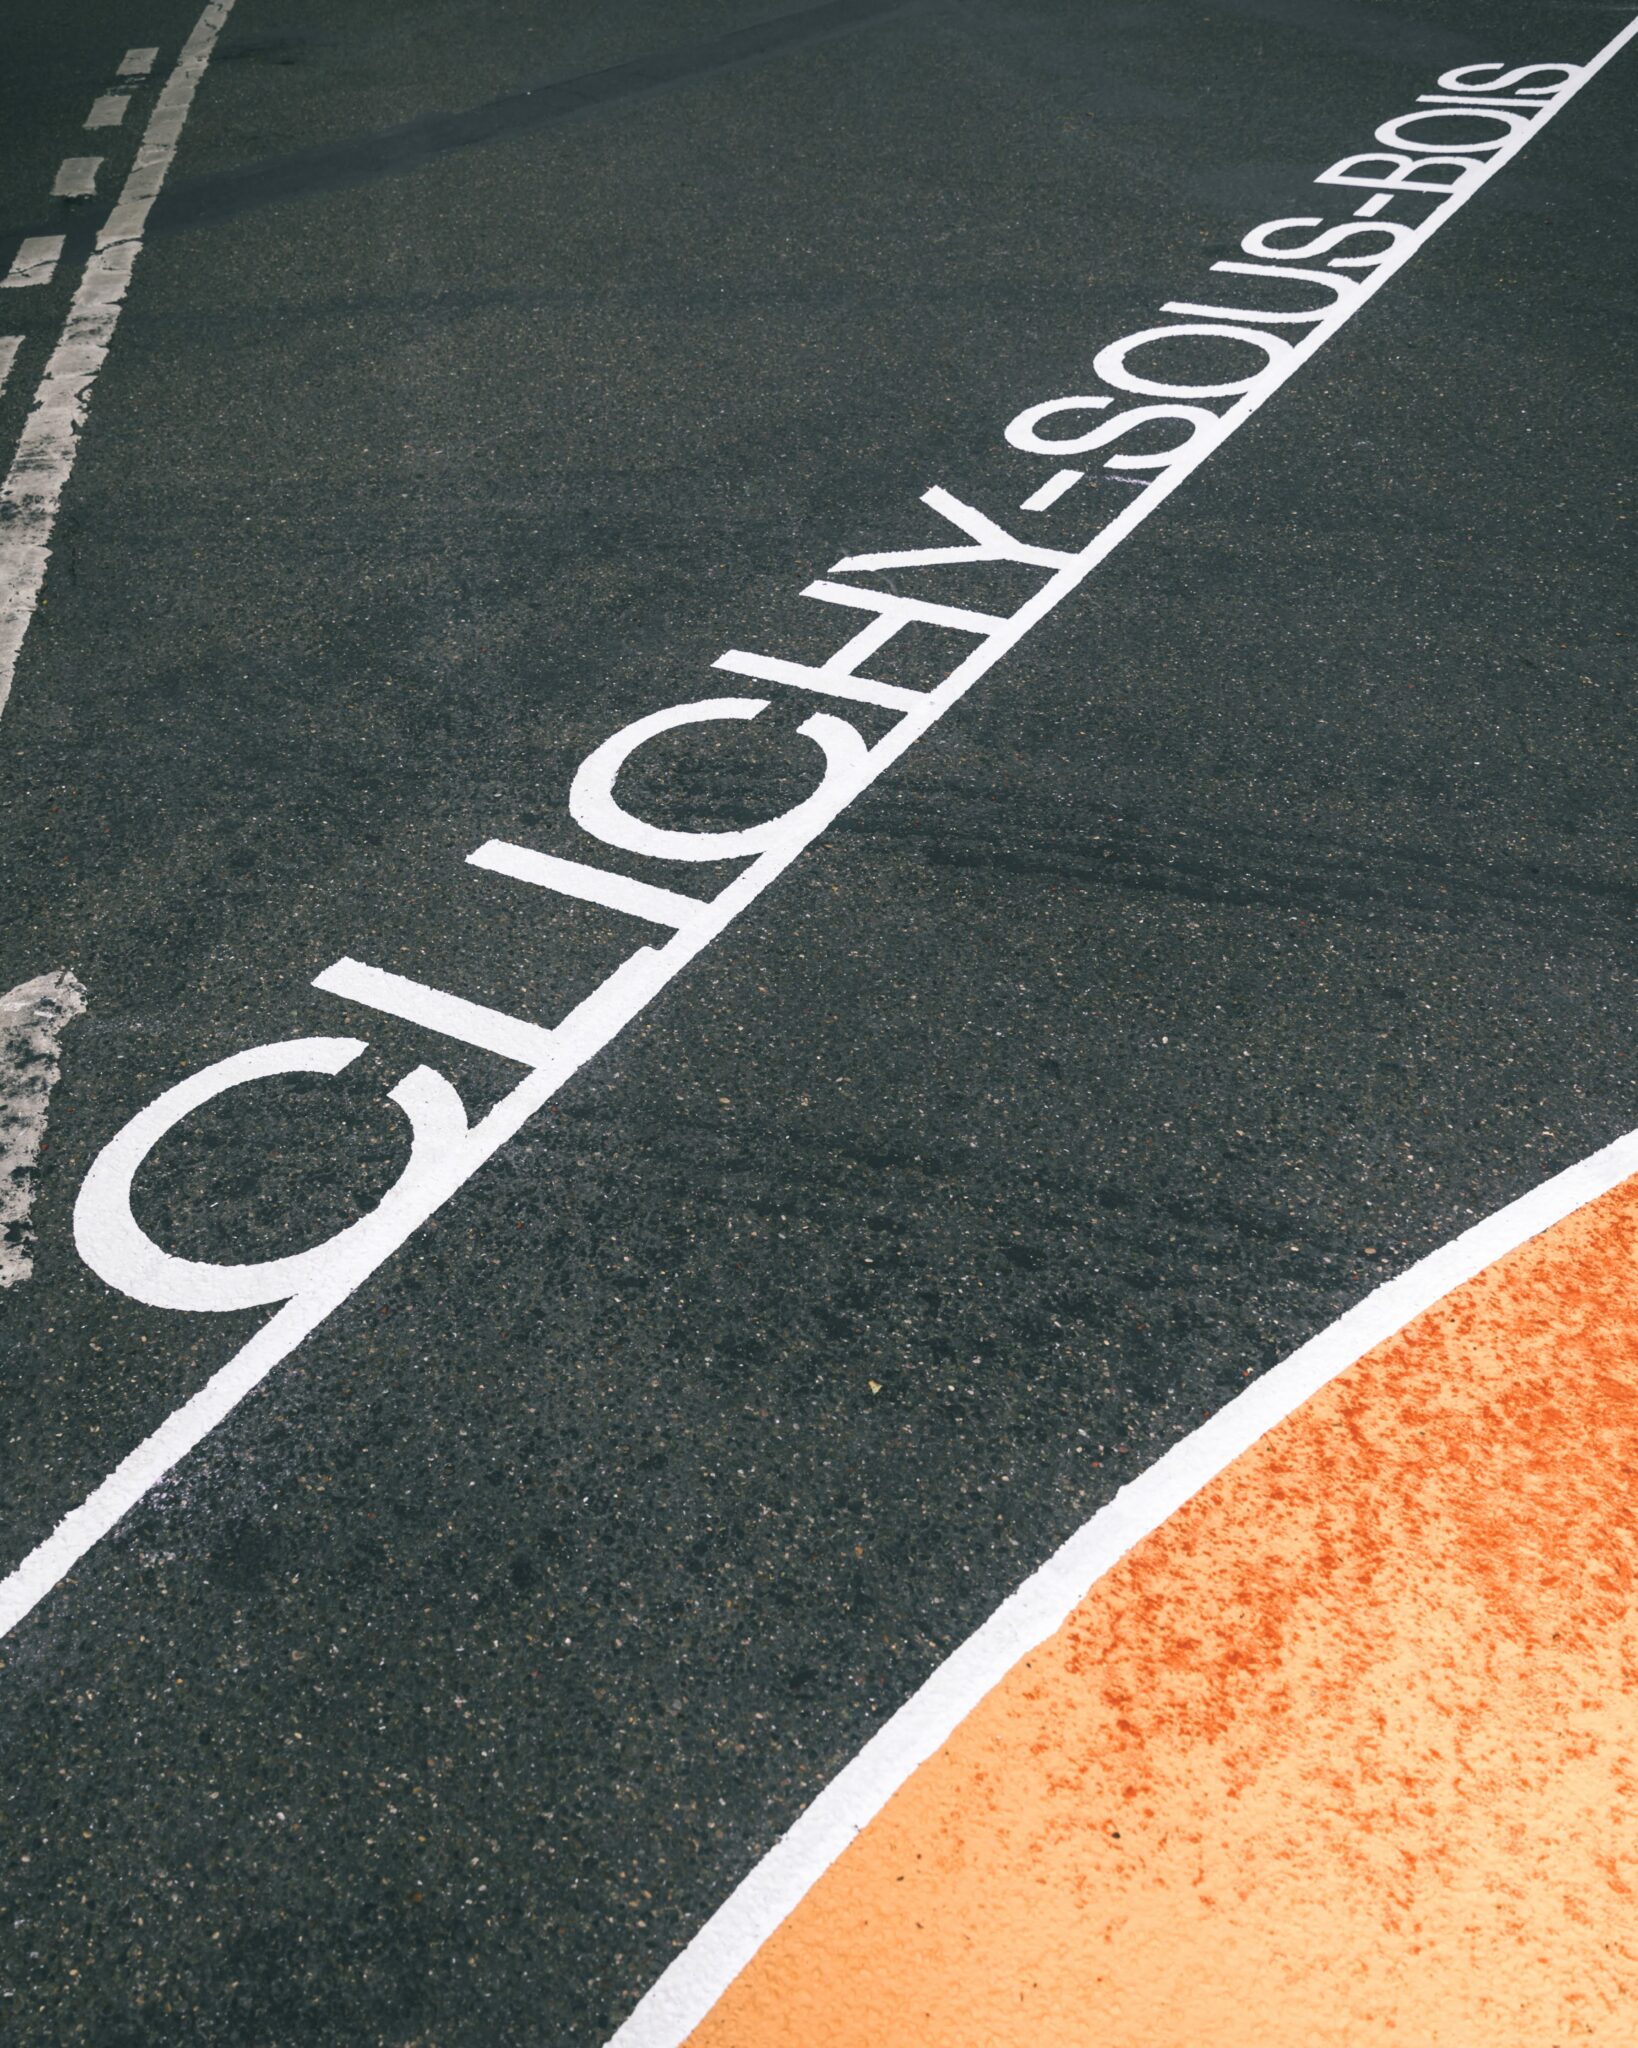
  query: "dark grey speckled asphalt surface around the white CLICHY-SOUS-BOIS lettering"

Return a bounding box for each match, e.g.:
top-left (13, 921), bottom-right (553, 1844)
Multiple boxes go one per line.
top-left (0, 0), bottom-right (1638, 2048)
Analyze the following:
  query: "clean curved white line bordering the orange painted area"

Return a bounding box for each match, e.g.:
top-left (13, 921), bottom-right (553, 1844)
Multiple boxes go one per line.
top-left (608, 1130), bottom-right (1638, 2048)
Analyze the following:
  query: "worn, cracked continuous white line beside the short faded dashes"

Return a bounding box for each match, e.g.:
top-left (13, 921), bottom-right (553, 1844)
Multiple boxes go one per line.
top-left (0, 0), bottom-right (233, 729)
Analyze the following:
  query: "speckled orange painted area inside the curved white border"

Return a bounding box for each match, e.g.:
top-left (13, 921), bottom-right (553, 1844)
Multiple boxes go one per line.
top-left (690, 1182), bottom-right (1638, 2048)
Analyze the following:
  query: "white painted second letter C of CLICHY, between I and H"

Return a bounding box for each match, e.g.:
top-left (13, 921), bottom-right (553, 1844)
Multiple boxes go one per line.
top-left (569, 696), bottom-right (870, 860)
